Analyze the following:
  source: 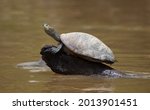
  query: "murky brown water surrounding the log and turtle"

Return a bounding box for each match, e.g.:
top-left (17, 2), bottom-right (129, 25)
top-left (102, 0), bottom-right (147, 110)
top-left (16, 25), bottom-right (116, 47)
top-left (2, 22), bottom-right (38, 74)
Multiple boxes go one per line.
top-left (0, 0), bottom-right (150, 92)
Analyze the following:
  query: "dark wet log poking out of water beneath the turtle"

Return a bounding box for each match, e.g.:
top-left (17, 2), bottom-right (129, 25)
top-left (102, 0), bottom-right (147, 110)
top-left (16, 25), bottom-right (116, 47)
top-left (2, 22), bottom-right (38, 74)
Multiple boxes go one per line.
top-left (40, 45), bottom-right (126, 77)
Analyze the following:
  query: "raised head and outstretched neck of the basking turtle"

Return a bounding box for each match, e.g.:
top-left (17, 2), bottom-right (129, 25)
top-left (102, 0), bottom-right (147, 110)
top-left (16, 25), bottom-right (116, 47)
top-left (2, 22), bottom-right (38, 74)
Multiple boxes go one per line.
top-left (43, 23), bottom-right (60, 42)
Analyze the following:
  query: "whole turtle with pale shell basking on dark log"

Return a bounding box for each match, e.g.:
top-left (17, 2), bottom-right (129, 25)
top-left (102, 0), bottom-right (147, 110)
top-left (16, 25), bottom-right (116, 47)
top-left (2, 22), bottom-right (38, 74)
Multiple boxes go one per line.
top-left (43, 23), bottom-right (116, 64)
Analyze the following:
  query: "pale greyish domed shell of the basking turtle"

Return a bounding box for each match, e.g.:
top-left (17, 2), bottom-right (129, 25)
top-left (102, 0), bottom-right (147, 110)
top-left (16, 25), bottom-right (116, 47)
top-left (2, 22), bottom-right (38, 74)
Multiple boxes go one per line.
top-left (60, 32), bottom-right (115, 63)
